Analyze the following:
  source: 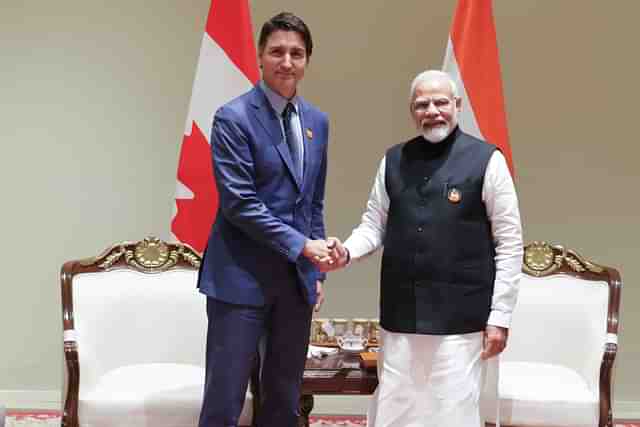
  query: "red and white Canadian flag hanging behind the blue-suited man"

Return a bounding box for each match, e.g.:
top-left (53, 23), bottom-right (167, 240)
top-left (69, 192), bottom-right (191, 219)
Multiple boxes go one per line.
top-left (171, 0), bottom-right (260, 253)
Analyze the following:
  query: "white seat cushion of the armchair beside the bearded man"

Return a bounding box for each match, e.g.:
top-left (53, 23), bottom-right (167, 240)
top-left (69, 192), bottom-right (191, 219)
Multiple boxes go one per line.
top-left (483, 362), bottom-right (599, 427)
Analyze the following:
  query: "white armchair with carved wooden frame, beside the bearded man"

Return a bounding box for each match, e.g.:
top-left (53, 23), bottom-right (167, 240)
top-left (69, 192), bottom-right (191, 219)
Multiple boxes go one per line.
top-left (482, 242), bottom-right (622, 427)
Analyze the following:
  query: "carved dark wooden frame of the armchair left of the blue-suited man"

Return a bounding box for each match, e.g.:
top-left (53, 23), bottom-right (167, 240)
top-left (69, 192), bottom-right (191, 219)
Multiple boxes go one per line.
top-left (60, 237), bottom-right (260, 427)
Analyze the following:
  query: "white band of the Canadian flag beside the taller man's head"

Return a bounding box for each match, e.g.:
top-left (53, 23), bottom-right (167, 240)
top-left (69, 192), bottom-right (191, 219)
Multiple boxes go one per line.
top-left (184, 32), bottom-right (253, 141)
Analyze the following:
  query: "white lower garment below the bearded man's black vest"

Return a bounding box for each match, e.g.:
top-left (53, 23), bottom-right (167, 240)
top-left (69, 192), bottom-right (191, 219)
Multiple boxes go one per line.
top-left (367, 329), bottom-right (496, 427)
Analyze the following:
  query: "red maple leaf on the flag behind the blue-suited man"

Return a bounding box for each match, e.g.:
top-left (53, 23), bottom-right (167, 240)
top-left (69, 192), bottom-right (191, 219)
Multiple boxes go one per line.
top-left (171, 122), bottom-right (218, 253)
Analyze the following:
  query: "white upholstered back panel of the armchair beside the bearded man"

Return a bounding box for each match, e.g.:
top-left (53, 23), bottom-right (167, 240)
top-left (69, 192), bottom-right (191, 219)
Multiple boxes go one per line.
top-left (500, 274), bottom-right (609, 390)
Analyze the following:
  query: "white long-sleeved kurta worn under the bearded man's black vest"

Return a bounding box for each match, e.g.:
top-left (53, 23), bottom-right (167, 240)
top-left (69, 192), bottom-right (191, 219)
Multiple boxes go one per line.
top-left (344, 151), bottom-right (523, 427)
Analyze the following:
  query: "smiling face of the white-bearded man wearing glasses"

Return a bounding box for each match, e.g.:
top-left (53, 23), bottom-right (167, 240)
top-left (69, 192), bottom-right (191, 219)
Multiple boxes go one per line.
top-left (410, 78), bottom-right (460, 143)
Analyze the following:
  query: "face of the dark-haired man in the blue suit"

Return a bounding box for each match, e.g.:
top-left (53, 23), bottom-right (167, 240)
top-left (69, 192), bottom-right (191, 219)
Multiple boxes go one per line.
top-left (258, 30), bottom-right (308, 99)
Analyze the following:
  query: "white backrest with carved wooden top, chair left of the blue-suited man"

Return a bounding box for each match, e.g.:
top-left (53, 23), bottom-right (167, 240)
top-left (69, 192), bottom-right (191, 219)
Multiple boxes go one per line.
top-left (62, 238), bottom-right (207, 390)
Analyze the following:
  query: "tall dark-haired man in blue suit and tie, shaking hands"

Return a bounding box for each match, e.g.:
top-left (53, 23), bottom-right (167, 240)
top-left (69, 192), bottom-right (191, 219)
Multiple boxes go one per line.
top-left (198, 13), bottom-right (330, 427)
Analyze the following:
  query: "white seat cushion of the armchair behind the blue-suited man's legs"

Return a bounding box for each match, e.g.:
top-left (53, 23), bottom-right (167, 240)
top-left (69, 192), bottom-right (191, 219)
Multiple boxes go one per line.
top-left (78, 363), bottom-right (252, 427)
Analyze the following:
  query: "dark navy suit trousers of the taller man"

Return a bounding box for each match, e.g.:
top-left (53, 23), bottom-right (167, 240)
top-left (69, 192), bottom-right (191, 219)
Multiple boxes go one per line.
top-left (199, 286), bottom-right (312, 427)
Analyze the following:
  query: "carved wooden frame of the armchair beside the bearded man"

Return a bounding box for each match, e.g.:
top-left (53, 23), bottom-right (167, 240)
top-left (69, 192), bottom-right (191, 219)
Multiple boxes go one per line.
top-left (523, 241), bottom-right (622, 427)
